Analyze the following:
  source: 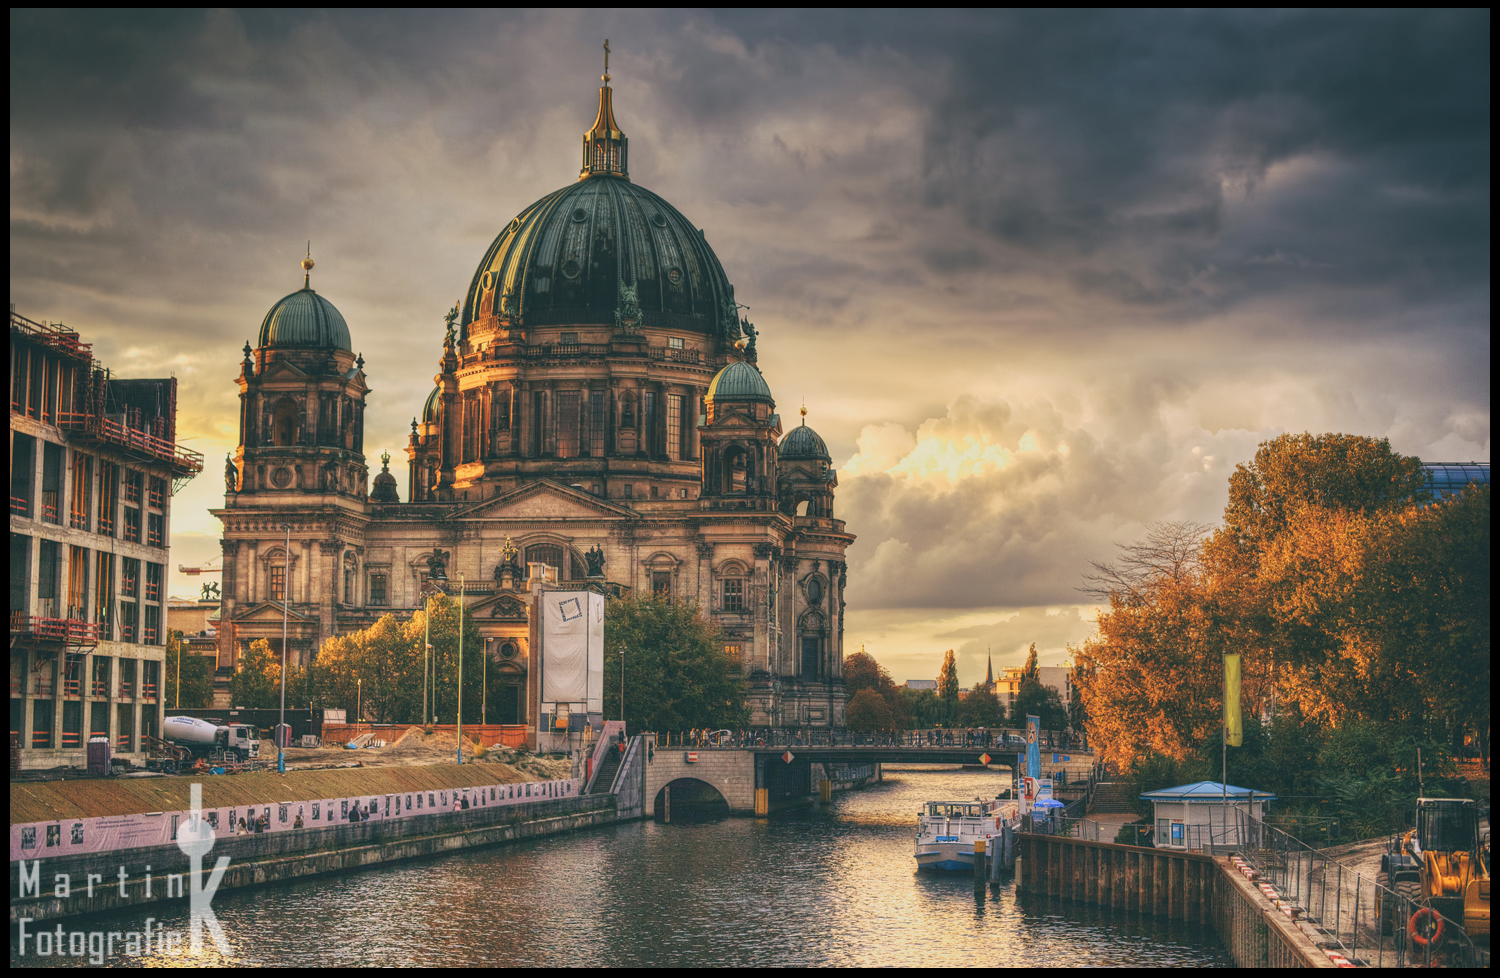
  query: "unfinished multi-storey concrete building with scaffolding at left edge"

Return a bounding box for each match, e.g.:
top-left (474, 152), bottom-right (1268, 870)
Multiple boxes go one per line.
top-left (11, 311), bottom-right (203, 768)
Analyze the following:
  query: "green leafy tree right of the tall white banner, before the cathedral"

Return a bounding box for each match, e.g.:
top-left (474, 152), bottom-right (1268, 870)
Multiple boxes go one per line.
top-left (605, 597), bottom-right (750, 731)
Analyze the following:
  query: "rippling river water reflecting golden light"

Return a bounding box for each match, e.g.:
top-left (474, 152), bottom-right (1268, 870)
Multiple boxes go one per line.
top-left (11, 771), bottom-right (1230, 968)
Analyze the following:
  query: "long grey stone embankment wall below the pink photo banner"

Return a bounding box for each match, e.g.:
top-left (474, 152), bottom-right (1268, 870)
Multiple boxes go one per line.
top-left (11, 795), bottom-right (621, 927)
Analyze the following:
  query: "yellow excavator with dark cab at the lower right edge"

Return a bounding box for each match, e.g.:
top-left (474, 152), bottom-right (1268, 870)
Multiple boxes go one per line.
top-left (1376, 798), bottom-right (1490, 945)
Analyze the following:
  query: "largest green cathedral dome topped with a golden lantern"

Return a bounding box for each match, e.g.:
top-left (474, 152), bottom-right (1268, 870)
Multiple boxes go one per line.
top-left (462, 86), bottom-right (737, 338)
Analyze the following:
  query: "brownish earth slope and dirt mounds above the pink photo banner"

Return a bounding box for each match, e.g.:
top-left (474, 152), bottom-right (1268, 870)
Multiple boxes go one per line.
top-left (11, 728), bottom-right (573, 825)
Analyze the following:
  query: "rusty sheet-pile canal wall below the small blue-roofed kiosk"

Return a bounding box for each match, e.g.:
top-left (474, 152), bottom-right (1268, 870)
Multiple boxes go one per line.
top-left (1016, 833), bottom-right (1337, 968)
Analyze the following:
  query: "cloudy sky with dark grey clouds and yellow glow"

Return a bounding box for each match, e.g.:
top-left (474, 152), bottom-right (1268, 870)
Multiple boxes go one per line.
top-left (11, 11), bottom-right (1490, 684)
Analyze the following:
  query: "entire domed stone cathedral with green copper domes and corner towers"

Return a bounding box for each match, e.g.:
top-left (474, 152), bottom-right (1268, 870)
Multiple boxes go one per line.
top-left (215, 74), bottom-right (854, 726)
